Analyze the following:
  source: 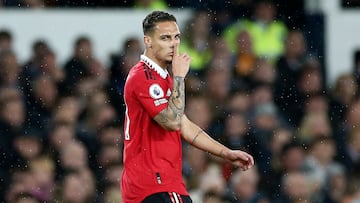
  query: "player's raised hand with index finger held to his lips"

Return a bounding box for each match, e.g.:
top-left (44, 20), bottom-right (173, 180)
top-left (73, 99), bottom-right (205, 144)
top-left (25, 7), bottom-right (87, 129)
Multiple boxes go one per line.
top-left (172, 43), bottom-right (191, 78)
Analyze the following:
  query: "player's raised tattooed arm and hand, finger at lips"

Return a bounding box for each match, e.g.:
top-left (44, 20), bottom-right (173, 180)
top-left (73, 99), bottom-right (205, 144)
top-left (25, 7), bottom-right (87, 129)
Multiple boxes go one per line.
top-left (154, 43), bottom-right (191, 130)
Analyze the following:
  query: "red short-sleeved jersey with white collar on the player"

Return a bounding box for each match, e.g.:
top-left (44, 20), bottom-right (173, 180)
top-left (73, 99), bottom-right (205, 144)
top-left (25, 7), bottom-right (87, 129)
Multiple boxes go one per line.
top-left (121, 55), bottom-right (188, 203)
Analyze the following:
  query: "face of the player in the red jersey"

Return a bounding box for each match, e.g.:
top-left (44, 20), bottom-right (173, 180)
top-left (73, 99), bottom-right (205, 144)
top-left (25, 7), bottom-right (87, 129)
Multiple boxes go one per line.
top-left (147, 21), bottom-right (180, 66)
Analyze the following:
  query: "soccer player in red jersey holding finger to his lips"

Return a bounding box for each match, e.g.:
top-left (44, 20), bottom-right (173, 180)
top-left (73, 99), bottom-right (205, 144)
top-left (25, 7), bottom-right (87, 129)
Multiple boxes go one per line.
top-left (121, 11), bottom-right (254, 203)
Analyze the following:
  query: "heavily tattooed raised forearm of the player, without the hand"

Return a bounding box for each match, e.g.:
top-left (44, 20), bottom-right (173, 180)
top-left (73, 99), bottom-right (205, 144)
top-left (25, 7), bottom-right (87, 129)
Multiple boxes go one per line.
top-left (155, 76), bottom-right (185, 130)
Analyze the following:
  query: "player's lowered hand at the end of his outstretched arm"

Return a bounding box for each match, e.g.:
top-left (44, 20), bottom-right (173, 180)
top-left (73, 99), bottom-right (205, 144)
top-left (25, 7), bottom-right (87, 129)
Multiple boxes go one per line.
top-left (222, 150), bottom-right (254, 171)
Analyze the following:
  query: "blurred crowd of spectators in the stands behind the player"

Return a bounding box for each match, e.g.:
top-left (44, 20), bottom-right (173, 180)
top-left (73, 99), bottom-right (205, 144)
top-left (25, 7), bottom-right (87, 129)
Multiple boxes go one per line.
top-left (0, 0), bottom-right (360, 203)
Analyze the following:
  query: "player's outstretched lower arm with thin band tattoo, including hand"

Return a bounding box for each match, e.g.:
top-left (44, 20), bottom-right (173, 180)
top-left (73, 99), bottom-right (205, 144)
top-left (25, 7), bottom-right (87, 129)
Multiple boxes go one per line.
top-left (181, 115), bottom-right (254, 170)
